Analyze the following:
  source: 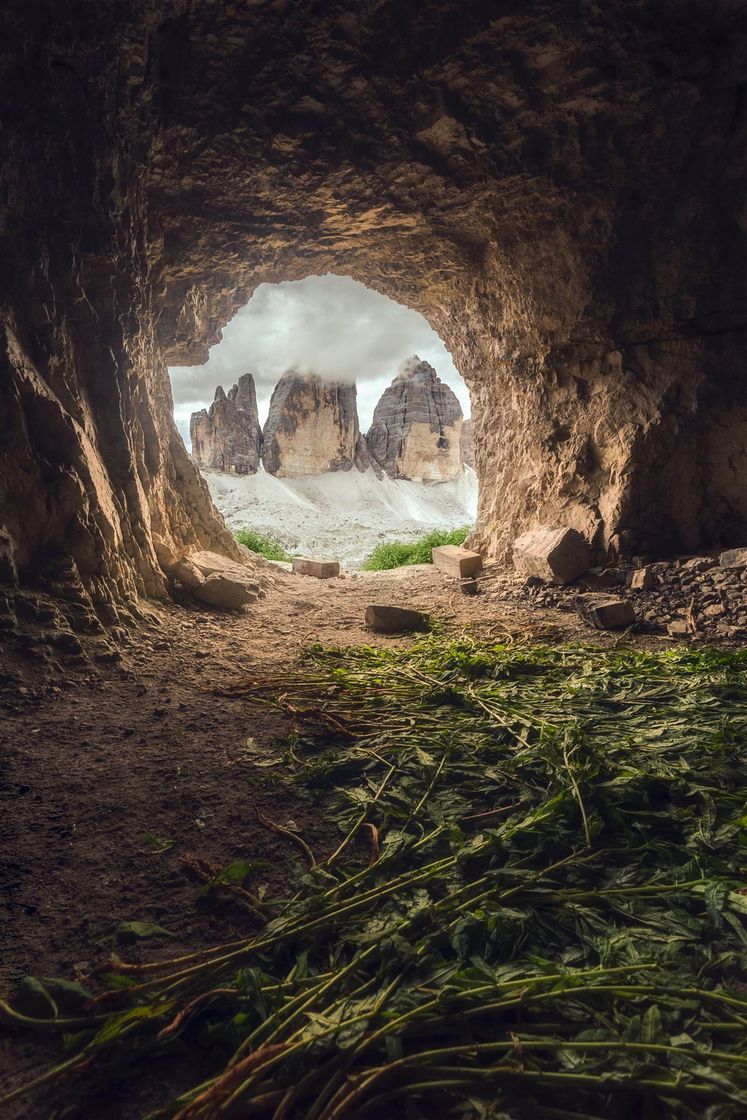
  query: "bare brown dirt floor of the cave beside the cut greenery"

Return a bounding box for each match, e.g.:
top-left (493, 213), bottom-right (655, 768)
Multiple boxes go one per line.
top-left (0, 567), bottom-right (725, 1118)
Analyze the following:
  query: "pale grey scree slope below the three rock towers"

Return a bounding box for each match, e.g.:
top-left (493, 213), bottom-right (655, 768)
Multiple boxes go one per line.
top-left (203, 467), bottom-right (477, 568)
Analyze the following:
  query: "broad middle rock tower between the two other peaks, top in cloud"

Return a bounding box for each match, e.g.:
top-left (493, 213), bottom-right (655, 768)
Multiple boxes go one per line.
top-left (262, 370), bottom-right (367, 478)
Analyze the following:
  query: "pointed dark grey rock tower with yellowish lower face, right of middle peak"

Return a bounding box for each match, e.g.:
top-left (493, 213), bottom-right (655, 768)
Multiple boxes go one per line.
top-left (366, 355), bottom-right (461, 483)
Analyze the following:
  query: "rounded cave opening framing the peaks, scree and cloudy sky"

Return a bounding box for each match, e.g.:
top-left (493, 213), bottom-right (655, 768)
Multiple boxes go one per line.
top-left (169, 274), bottom-right (477, 568)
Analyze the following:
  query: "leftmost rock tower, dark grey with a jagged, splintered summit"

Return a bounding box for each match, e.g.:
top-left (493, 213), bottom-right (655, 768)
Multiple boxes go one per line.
top-left (189, 373), bottom-right (262, 475)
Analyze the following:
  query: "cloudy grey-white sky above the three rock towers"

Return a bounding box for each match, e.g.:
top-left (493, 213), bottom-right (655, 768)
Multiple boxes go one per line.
top-left (169, 274), bottom-right (470, 447)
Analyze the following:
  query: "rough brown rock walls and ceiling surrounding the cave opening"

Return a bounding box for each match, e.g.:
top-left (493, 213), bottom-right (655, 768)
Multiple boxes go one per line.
top-left (0, 0), bottom-right (747, 600)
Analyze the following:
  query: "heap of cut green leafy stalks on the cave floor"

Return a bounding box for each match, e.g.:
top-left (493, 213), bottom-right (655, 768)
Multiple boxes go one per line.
top-left (6, 637), bottom-right (747, 1120)
